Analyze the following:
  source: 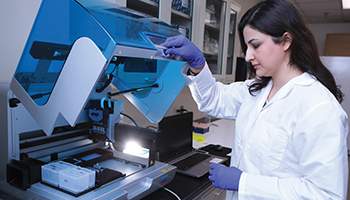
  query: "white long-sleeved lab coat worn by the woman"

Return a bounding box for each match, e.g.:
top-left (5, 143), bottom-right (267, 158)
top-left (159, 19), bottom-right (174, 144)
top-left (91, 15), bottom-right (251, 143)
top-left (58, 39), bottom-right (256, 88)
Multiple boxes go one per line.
top-left (182, 64), bottom-right (348, 200)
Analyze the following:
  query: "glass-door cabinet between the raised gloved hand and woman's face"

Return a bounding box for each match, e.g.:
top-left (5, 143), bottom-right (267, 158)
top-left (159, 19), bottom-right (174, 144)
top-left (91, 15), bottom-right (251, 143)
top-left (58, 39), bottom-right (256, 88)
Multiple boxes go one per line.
top-left (192, 0), bottom-right (241, 82)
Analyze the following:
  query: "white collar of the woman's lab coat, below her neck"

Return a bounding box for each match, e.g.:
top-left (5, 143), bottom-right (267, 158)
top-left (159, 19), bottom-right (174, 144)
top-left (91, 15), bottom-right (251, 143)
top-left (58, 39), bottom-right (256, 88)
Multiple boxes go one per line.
top-left (259, 72), bottom-right (316, 105)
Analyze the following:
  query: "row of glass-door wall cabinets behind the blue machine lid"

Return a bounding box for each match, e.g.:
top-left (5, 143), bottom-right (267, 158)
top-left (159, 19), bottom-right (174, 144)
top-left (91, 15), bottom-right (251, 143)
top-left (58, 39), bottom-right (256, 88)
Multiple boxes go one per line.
top-left (109, 0), bottom-right (241, 82)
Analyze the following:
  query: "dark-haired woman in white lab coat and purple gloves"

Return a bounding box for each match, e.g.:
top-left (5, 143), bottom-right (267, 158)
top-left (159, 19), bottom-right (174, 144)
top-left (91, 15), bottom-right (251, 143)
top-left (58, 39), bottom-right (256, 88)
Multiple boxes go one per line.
top-left (163, 0), bottom-right (348, 199)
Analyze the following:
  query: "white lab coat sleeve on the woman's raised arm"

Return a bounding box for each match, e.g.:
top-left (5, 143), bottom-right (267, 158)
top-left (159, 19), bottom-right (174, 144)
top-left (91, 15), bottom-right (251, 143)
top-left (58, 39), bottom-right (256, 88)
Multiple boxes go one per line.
top-left (182, 63), bottom-right (249, 119)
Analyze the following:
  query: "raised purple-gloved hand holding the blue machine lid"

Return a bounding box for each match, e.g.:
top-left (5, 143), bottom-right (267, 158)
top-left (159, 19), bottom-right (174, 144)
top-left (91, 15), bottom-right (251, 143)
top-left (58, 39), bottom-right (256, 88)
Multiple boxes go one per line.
top-left (160, 34), bottom-right (205, 68)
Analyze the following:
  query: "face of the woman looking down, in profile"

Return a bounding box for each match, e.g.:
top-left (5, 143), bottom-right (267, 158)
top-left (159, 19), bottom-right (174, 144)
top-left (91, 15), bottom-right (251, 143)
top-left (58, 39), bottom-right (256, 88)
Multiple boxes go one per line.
top-left (243, 26), bottom-right (289, 78)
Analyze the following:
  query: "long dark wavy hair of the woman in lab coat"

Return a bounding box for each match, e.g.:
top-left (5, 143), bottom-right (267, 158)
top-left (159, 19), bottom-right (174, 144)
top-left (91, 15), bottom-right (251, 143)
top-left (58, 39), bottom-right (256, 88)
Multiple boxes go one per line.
top-left (238, 0), bottom-right (344, 103)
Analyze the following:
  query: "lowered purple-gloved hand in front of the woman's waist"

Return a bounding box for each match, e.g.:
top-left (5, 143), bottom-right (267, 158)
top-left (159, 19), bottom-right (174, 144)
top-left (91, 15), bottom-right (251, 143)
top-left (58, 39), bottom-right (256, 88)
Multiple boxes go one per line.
top-left (209, 163), bottom-right (242, 191)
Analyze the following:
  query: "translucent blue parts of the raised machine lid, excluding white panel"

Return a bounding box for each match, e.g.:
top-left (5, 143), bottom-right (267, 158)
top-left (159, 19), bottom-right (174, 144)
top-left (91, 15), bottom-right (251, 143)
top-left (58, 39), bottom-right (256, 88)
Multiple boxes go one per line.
top-left (13, 0), bottom-right (185, 134)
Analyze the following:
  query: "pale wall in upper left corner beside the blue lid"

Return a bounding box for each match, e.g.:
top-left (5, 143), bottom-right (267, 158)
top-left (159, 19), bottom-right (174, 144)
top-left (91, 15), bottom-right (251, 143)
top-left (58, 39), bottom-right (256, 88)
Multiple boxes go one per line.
top-left (0, 0), bottom-right (41, 81)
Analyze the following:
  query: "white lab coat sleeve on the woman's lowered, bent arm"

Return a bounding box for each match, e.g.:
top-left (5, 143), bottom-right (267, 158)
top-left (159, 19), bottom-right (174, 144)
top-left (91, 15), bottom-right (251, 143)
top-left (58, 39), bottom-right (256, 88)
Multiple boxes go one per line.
top-left (238, 102), bottom-right (348, 199)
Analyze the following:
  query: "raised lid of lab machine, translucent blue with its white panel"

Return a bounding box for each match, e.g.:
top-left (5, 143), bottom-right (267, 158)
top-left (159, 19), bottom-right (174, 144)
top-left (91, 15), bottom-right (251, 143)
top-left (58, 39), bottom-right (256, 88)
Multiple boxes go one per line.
top-left (10, 0), bottom-right (185, 135)
